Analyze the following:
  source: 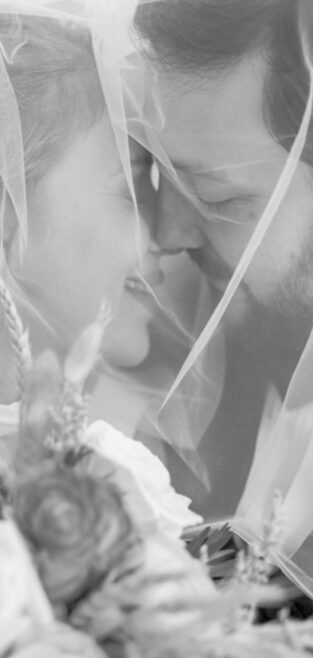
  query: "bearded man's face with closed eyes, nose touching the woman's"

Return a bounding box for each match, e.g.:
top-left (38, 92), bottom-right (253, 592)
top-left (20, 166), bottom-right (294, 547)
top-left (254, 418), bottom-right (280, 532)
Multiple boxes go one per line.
top-left (152, 58), bottom-right (313, 382)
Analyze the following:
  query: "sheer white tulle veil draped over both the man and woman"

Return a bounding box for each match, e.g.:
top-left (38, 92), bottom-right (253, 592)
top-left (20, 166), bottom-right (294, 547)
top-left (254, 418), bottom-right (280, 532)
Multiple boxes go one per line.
top-left (0, 0), bottom-right (313, 597)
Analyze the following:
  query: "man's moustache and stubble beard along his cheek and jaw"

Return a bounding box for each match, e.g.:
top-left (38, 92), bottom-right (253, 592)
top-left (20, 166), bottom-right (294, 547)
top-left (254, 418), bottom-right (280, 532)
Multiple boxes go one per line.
top-left (188, 214), bottom-right (313, 395)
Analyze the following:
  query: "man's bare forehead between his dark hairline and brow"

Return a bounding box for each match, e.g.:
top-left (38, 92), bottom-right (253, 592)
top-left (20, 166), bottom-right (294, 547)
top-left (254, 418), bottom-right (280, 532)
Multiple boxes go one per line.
top-left (151, 59), bottom-right (282, 182)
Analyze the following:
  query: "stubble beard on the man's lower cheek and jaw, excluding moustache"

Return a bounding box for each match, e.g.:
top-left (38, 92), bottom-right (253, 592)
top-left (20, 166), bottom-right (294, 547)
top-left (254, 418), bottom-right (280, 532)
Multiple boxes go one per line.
top-left (215, 266), bottom-right (313, 395)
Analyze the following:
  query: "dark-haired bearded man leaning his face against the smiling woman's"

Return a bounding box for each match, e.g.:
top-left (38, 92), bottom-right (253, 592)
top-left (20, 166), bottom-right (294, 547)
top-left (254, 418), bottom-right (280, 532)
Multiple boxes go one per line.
top-left (136, 0), bottom-right (313, 515)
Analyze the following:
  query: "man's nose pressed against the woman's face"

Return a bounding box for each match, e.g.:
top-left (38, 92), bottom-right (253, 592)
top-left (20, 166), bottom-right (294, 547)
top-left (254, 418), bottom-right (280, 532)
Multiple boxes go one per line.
top-left (154, 177), bottom-right (205, 251)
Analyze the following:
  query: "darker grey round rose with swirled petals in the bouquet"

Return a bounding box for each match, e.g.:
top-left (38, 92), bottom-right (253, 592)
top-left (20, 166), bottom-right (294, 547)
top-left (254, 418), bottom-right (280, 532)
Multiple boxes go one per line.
top-left (13, 464), bottom-right (132, 605)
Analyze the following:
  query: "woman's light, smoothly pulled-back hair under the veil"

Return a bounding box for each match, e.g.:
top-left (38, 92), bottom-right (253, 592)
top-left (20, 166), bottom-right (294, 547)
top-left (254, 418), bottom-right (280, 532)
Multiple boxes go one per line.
top-left (0, 15), bottom-right (104, 183)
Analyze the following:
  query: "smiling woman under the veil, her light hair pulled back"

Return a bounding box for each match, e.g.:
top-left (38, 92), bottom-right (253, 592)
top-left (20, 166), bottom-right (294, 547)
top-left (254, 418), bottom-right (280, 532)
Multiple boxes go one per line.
top-left (0, 5), bottom-right (162, 410)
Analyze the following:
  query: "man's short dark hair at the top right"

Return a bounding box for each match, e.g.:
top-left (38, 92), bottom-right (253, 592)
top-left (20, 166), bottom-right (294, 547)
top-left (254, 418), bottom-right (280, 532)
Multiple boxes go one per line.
top-left (135, 0), bottom-right (313, 164)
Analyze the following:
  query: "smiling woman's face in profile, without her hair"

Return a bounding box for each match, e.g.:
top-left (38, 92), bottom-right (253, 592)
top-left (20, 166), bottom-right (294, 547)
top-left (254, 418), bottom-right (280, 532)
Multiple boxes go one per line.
top-left (10, 116), bottom-right (158, 366)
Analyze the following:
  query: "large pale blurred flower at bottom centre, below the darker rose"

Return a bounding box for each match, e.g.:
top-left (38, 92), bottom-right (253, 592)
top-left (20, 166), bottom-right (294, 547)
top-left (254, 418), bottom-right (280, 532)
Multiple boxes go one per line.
top-left (70, 534), bottom-right (219, 658)
